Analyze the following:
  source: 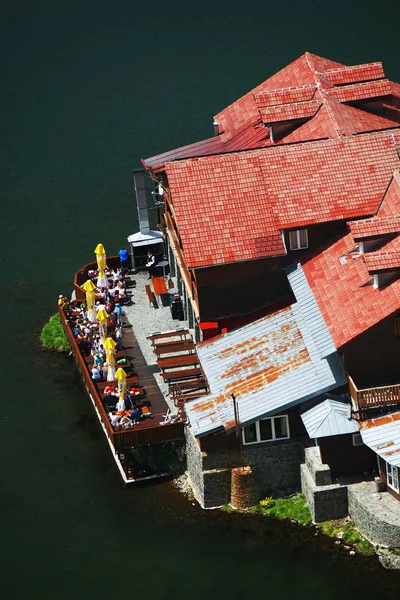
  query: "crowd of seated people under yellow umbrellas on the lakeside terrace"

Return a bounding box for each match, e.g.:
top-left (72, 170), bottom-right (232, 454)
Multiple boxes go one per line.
top-left (58, 269), bottom-right (151, 431)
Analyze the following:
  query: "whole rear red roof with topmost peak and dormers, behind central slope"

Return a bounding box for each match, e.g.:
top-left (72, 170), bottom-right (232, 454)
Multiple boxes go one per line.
top-left (143, 52), bottom-right (400, 168)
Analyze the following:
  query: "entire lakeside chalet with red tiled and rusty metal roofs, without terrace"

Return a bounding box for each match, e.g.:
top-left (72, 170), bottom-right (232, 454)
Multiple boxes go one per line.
top-left (134, 53), bottom-right (400, 520)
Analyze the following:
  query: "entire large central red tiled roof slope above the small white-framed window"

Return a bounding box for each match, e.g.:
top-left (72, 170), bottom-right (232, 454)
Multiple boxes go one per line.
top-left (166, 131), bottom-right (400, 267)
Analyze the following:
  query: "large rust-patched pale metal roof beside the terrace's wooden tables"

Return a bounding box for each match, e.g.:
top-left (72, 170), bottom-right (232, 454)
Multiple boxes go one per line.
top-left (186, 306), bottom-right (346, 437)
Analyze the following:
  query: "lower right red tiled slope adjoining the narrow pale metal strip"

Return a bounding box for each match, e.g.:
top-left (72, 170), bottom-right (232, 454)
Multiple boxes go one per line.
top-left (303, 233), bottom-right (400, 348)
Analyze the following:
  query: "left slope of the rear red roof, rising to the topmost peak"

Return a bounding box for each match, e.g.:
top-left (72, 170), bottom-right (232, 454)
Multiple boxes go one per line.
top-left (214, 52), bottom-right (344, 142)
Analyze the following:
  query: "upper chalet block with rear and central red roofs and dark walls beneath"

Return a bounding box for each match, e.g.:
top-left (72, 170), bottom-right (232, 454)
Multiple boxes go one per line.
top-left (143, 53), bottom-right (400, 339)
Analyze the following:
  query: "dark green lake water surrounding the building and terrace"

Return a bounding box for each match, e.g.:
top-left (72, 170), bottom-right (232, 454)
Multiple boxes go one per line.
top-left (0, 0), bottom-right (400, 600)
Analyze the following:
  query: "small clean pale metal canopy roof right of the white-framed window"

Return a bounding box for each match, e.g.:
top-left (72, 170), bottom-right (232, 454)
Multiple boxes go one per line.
top-left (301, 395), bottom-right (358, 438)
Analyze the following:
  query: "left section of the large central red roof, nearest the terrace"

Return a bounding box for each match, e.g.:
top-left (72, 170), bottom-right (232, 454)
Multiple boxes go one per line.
top-left (166, 151), bottom-right (286, 267)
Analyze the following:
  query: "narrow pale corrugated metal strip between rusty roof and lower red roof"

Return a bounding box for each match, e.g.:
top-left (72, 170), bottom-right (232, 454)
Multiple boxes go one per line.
top-left (286, 263), bottom-right (336, 358)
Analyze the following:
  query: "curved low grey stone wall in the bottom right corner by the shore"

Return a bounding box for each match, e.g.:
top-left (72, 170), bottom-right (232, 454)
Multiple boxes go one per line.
top-left (348, 482), bottom-right (400, 548)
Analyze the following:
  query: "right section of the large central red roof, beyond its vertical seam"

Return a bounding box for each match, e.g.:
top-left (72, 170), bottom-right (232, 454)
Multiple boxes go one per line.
top-left (266, 132), bottom-right (400, 229)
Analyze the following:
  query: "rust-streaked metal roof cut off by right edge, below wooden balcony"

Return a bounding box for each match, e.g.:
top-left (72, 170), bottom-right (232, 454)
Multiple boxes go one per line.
top-left (360, 412), bottom-right (400, 467)
